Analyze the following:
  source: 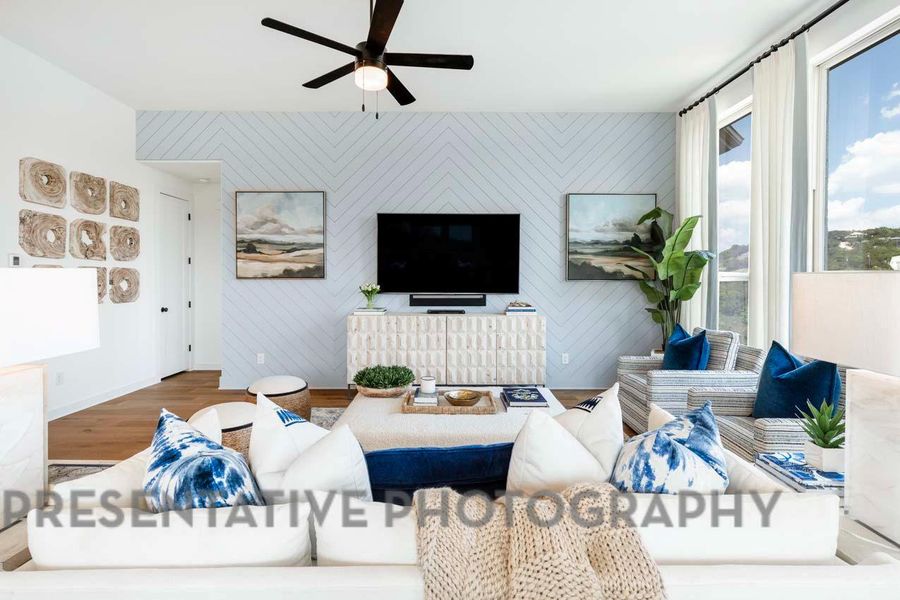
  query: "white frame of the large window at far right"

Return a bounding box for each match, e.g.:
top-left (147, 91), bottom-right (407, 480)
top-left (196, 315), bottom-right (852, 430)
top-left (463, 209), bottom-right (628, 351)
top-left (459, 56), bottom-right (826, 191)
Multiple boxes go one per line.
top-left (809, 18), bottom-right (900, 272)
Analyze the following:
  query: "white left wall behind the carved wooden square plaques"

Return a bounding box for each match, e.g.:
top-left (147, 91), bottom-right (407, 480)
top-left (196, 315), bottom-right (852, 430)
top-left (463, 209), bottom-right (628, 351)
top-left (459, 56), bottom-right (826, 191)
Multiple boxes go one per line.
top-left (0, 37), bottom-right (192, 418)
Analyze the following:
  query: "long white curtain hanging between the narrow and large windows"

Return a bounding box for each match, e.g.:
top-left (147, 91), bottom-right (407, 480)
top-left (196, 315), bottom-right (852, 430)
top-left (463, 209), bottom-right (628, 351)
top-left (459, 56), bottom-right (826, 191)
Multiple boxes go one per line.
top-left (748, 42), bottom-right (796, 349)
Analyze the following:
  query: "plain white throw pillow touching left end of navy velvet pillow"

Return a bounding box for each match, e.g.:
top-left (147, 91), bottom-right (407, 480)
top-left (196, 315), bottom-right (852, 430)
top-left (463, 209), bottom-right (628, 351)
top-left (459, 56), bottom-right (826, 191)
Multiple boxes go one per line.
top-left (276, 425), bottom-right (372, 502)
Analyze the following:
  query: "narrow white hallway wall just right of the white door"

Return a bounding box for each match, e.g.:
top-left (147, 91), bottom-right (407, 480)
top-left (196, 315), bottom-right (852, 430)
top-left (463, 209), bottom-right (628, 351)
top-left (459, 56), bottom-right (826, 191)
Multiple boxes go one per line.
top-left (191, 183), bottom-right (222, 370)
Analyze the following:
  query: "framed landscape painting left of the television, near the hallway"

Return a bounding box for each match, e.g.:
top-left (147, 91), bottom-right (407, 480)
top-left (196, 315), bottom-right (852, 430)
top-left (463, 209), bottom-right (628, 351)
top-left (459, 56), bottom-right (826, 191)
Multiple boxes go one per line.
top-left (234, 191), bottom-right (325, 279)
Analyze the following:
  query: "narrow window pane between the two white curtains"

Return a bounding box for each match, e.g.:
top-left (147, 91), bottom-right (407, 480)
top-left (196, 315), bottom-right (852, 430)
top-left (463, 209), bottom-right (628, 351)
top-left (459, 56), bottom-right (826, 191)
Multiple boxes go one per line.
top-left (718, 113), bottom-right (752, 340)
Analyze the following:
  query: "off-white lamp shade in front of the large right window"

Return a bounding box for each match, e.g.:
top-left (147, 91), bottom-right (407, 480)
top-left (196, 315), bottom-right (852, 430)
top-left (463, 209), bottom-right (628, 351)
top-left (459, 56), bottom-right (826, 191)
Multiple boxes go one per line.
top-left (791, 271), bottom-right (900, 376)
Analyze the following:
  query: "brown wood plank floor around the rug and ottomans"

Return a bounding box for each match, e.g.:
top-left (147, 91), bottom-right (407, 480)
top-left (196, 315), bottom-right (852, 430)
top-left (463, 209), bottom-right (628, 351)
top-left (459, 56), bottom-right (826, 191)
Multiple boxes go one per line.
top-left (49, 371), bottom-right (598, 462)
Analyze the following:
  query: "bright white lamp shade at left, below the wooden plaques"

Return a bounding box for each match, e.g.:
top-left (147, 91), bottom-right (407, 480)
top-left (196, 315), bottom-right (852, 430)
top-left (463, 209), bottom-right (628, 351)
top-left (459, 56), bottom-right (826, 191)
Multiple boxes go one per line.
top-left (0, 269), bottom-right (100, 367)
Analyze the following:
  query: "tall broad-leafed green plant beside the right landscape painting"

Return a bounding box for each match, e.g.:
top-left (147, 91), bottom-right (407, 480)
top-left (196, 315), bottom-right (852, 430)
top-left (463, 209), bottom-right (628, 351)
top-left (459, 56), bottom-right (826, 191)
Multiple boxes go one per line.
top-left (626, 206), bottom-right (714, 345)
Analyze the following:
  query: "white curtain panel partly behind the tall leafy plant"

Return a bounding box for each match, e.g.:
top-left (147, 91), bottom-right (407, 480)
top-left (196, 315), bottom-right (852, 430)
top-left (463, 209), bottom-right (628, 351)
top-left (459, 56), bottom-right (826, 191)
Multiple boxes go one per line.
top-left (675, 99), bottom-right (715, 331)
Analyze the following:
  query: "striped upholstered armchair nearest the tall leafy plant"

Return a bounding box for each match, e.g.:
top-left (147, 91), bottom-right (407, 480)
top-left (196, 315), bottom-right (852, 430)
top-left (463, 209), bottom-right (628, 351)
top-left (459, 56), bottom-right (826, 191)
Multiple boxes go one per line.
top-left (617, 328), bottom-right (765, 433)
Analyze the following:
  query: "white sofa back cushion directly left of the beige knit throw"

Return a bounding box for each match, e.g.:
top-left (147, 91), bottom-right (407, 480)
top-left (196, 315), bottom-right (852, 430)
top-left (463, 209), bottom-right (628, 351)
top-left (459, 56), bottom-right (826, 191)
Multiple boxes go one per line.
top-left (314, 492), bottom-right (417, 567)
